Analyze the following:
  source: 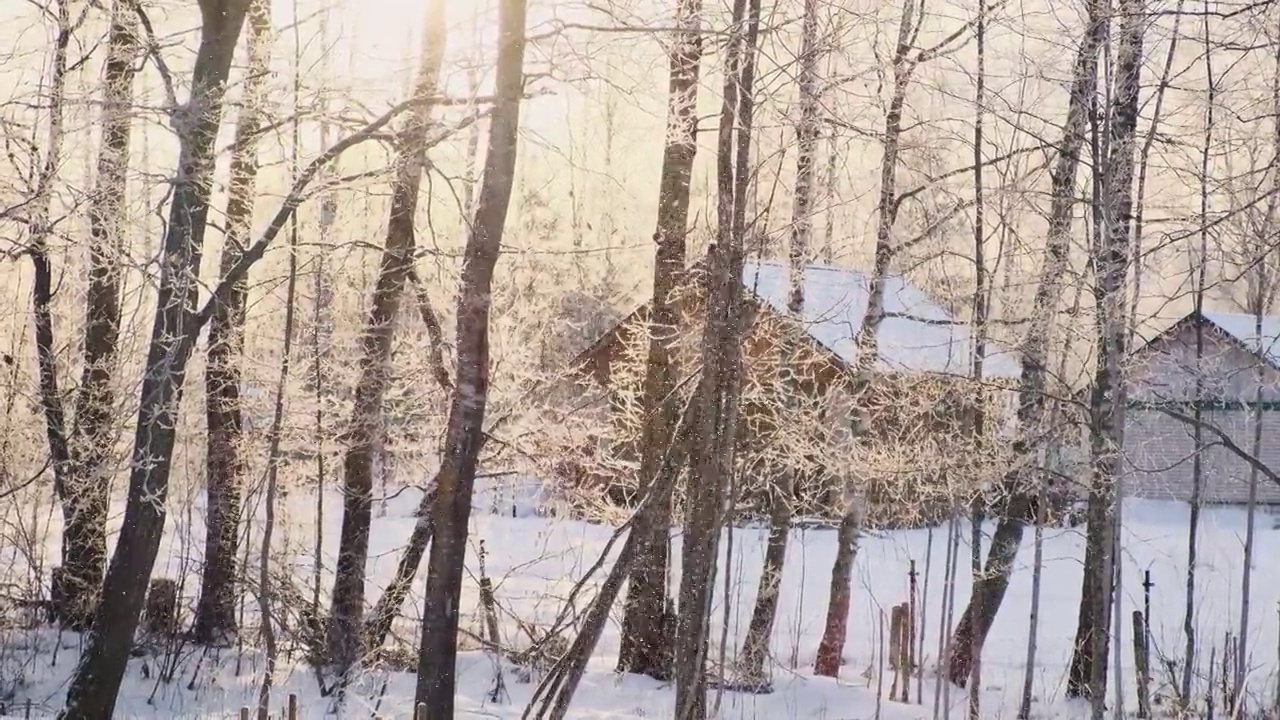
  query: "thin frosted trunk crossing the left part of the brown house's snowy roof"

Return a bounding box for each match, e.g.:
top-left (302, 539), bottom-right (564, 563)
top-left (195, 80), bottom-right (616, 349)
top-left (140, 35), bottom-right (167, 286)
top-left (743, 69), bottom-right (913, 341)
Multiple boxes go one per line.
top-left (737, 0), bottom-right (820, 687)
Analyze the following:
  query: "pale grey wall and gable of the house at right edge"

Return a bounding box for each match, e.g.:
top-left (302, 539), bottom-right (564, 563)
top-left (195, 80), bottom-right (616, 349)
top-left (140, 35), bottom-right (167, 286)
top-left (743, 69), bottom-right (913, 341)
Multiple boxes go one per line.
top-left (1124, 324), bottom-right (1280, 503)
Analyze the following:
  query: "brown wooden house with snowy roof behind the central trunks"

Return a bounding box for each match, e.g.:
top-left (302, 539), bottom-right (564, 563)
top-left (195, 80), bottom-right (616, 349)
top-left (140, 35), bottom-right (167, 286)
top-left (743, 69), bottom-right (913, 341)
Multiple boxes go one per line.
top-left (550, 261), bottom-right (1020, 523)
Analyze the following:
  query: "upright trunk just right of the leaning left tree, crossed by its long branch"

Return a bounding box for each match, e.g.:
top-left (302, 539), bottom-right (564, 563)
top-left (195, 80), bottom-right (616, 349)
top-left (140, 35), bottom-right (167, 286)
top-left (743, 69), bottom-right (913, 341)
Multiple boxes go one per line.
top-left (195, 0), bottom-right (271, 644)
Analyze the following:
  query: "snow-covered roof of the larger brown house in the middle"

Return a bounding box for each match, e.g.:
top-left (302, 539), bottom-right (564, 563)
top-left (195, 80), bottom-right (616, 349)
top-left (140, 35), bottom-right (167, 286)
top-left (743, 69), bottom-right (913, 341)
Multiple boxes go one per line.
top-left (742, 261), bottom-right (1021, 378)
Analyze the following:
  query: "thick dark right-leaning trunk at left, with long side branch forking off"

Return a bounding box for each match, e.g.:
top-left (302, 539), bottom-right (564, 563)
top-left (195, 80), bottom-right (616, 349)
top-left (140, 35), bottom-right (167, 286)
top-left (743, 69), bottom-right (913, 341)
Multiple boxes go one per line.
top-left (63, 0), bottom-right (248, 720)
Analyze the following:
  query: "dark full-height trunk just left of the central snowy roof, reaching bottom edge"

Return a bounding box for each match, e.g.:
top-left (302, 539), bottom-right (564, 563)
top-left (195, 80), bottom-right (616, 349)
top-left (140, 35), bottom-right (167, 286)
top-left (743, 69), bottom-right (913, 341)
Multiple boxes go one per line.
top-left (675, 0), bottom-right (760, 720)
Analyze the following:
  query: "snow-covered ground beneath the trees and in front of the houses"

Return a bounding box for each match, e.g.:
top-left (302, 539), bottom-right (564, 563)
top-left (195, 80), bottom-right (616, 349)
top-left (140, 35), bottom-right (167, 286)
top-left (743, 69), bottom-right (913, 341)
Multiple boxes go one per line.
top-left (0, 476), bottom-right (1280, 720)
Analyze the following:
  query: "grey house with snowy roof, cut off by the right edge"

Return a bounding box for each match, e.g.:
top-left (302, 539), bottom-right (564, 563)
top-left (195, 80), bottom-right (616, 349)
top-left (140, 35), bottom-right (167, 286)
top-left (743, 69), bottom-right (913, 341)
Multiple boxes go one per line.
top-left (1121, 313), bottom-right (1280, 505)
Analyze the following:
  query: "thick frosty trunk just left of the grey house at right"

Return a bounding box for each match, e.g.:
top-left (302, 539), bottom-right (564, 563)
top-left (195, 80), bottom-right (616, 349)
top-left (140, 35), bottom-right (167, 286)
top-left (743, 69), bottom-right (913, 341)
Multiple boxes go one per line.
top-left (1068, 0), bottom-right (1147, 707)
